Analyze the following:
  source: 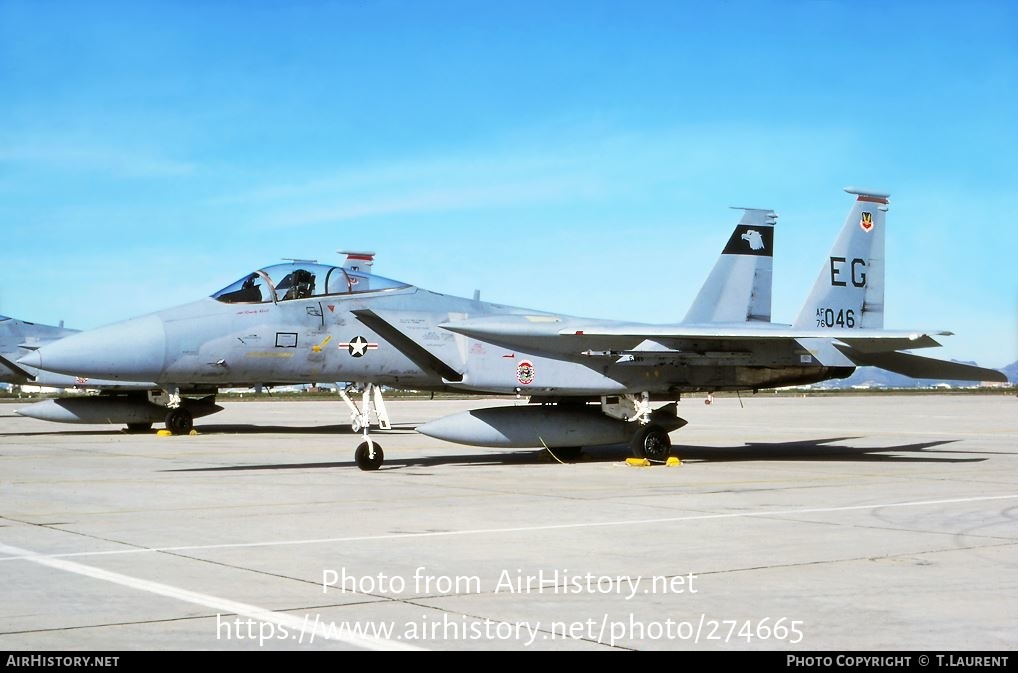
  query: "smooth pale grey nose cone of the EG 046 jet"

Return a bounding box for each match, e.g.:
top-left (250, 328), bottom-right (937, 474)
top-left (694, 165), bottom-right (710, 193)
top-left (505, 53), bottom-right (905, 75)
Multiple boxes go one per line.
top-left (18, 316), bottom-right (166, 381)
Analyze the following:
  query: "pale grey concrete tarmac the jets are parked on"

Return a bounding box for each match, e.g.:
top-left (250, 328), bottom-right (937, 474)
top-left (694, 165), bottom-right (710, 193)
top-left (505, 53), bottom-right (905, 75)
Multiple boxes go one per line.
top-left (0, 392), bottom-right (1018, 652)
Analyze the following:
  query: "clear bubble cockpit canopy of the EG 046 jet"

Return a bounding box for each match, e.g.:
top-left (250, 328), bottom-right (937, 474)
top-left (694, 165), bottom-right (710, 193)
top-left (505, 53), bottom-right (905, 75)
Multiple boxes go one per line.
top-left (212, 262), bottom-right (408, 303)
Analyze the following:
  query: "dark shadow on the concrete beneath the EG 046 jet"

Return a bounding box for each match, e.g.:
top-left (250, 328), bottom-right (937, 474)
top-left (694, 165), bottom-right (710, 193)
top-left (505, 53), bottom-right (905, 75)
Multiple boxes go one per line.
top-left (163, 431), bottom-right (998, 472)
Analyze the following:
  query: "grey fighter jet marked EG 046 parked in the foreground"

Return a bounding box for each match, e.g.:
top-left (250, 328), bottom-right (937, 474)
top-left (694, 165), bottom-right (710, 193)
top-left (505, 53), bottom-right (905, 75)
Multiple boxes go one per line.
top-left (19, 188), bottom-right (1004, 469)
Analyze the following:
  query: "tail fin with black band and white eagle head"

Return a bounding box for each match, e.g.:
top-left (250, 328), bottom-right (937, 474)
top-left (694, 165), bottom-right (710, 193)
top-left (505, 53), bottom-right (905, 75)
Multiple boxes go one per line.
top-left (682, 208), bottom-right (778, 324)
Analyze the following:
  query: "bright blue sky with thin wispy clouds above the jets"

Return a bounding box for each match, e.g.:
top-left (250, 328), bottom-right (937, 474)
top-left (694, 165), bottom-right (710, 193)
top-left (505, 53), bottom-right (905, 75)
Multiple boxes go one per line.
top-left (0, 0), bottom-right (1018, 367)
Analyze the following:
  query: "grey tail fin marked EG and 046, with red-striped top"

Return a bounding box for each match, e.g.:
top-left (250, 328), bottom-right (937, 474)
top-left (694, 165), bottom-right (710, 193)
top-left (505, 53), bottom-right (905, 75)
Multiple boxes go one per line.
top-left (795, 187), bottom-right (890, 329)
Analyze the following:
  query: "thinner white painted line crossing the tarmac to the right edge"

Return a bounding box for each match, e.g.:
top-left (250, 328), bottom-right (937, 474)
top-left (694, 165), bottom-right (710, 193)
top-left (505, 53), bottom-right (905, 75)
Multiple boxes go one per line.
top-left (0, 494), bottom-right (1018, 563)
